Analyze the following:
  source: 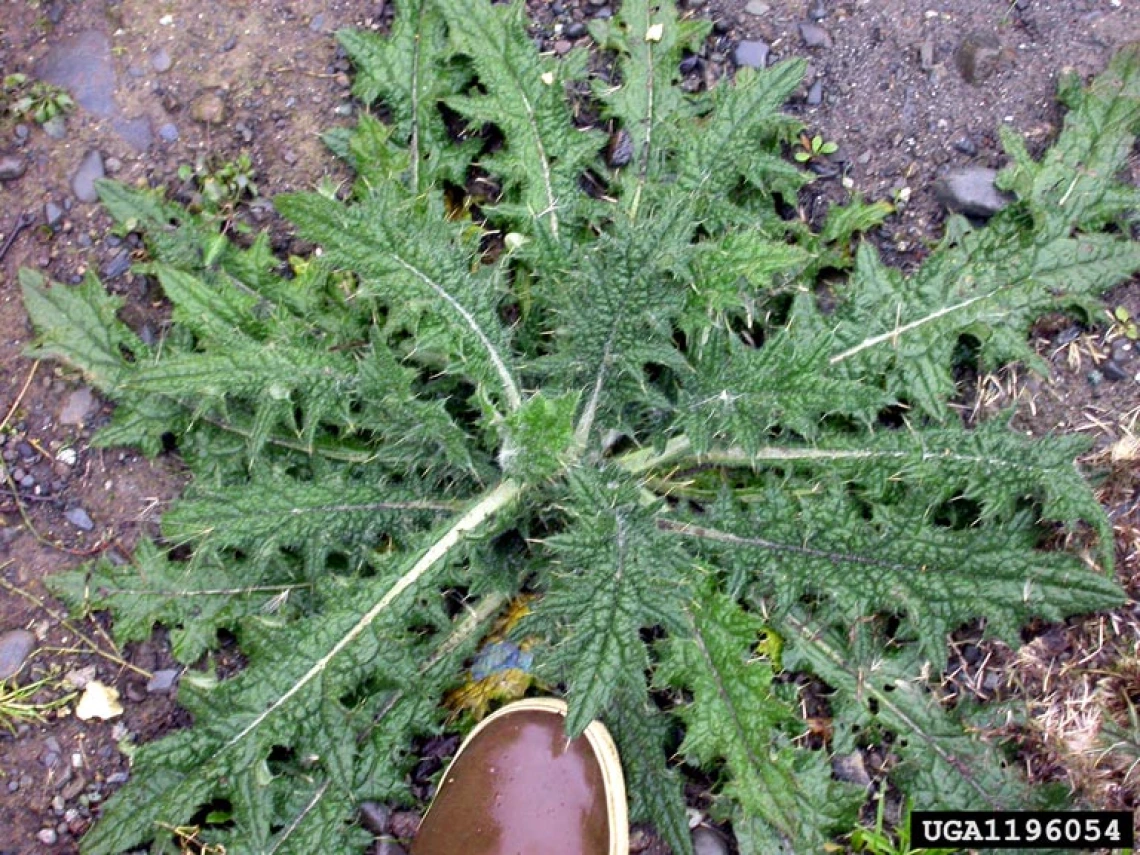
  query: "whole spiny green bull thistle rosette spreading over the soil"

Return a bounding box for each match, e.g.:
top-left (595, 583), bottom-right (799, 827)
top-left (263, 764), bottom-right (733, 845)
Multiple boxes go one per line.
top-left (15, 0), bottom-right (1140, 855)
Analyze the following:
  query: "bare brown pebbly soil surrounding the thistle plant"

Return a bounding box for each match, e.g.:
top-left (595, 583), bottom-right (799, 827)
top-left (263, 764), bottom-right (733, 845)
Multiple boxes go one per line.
top-left (0, 0), bottom-right (1140, 855)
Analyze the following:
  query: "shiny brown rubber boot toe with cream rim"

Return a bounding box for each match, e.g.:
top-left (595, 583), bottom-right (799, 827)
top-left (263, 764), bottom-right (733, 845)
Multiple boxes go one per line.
top-left (412, 698), bottom-right (629, 855)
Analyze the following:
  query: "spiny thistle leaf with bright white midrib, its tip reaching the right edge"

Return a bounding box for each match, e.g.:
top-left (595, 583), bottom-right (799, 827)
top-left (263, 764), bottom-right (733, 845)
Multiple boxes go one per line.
top-left (829, 225), bottom-right (1140, 420)
